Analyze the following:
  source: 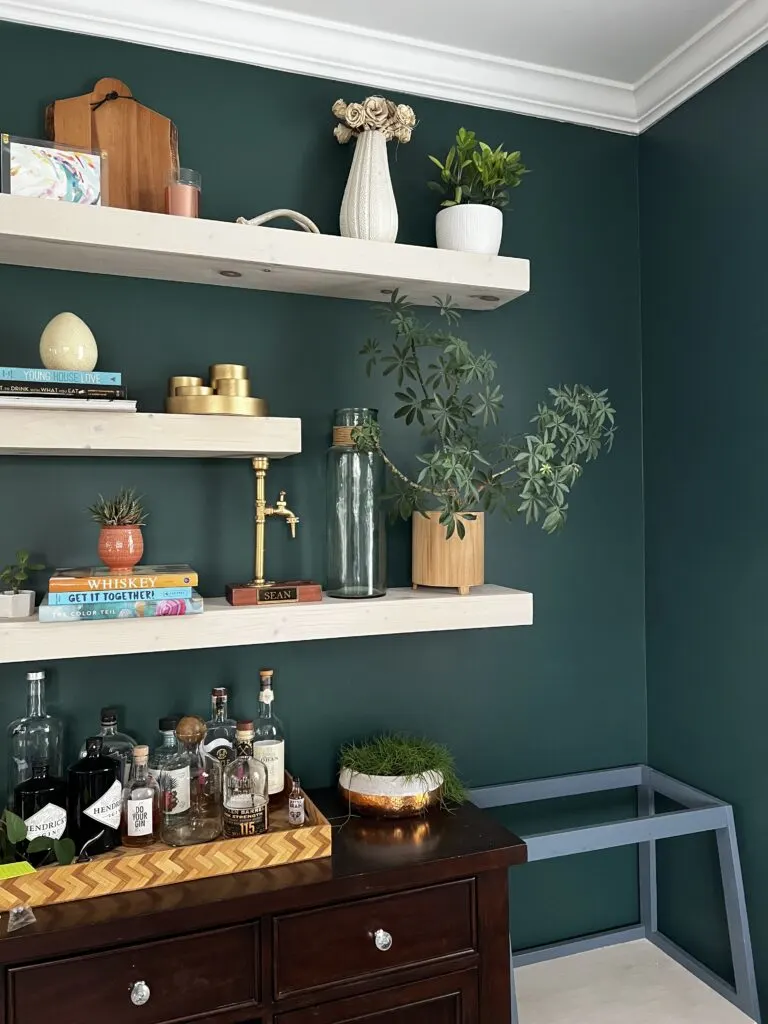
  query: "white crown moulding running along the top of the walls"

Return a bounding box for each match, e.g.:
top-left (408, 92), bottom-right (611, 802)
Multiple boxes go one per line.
top-left (0, 0), bottom-right (768, 134)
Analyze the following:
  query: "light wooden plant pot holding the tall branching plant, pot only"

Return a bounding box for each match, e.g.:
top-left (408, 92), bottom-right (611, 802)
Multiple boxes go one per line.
top-left (411, 512), bottom-right (485, 595)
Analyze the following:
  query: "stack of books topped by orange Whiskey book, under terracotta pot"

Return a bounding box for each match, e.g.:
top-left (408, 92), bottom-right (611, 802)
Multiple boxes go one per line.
top-left (38, 565), bottom-right (203, 623)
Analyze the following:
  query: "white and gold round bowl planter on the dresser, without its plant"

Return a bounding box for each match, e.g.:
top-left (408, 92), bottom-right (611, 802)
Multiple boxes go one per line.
top-left (339, 768), bottom-right (442, 818)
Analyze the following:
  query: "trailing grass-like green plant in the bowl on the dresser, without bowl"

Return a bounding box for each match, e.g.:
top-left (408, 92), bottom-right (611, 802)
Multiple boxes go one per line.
top-left (339, 733), bottom-right (467, 804)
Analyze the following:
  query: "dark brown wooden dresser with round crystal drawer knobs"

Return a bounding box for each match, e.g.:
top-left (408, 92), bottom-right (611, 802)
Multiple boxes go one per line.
top-left (0, 791), bottom-right (525, 1024)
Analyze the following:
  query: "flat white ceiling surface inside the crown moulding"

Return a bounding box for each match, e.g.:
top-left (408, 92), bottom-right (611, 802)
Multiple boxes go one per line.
top-left (252, 0), bottom-right (733, 84)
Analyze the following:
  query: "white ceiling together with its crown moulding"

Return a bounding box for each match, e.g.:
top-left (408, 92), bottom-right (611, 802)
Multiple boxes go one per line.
top-left (0, 0), bottom-right (768, 134)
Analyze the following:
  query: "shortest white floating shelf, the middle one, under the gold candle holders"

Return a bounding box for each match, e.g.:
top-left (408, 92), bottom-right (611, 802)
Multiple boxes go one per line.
top-left (0, 409), bottom-right (301, 459)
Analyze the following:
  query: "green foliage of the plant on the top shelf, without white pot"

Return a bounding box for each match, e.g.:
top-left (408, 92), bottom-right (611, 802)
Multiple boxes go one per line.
top-left (427, 128), bottom-right (529, 210)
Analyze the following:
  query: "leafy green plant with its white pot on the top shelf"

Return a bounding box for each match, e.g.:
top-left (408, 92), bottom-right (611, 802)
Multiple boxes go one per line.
top-left (427, 128), bottom-right (528, 256)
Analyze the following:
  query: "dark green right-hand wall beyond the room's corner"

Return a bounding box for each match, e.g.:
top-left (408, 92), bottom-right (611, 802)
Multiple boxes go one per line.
top-left (640, 50), bottom-right (768, 996)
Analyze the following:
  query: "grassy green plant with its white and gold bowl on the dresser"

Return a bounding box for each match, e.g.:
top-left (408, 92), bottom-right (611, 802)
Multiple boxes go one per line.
top-left (339, 734), bottom-right (466, 818)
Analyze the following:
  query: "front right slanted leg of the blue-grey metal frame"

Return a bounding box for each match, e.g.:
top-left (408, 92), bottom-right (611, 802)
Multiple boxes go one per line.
top-left (716, 807), bottom-right (760, 1024)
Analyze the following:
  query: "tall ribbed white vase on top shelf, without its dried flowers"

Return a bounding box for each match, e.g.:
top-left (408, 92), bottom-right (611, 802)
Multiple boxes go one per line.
top-left (339, 131), bottom-right (397, 242)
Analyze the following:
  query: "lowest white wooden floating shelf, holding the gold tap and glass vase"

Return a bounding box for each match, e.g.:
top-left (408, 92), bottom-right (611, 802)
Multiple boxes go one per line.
top-left (0, 586), bottom-right (534, 664)
